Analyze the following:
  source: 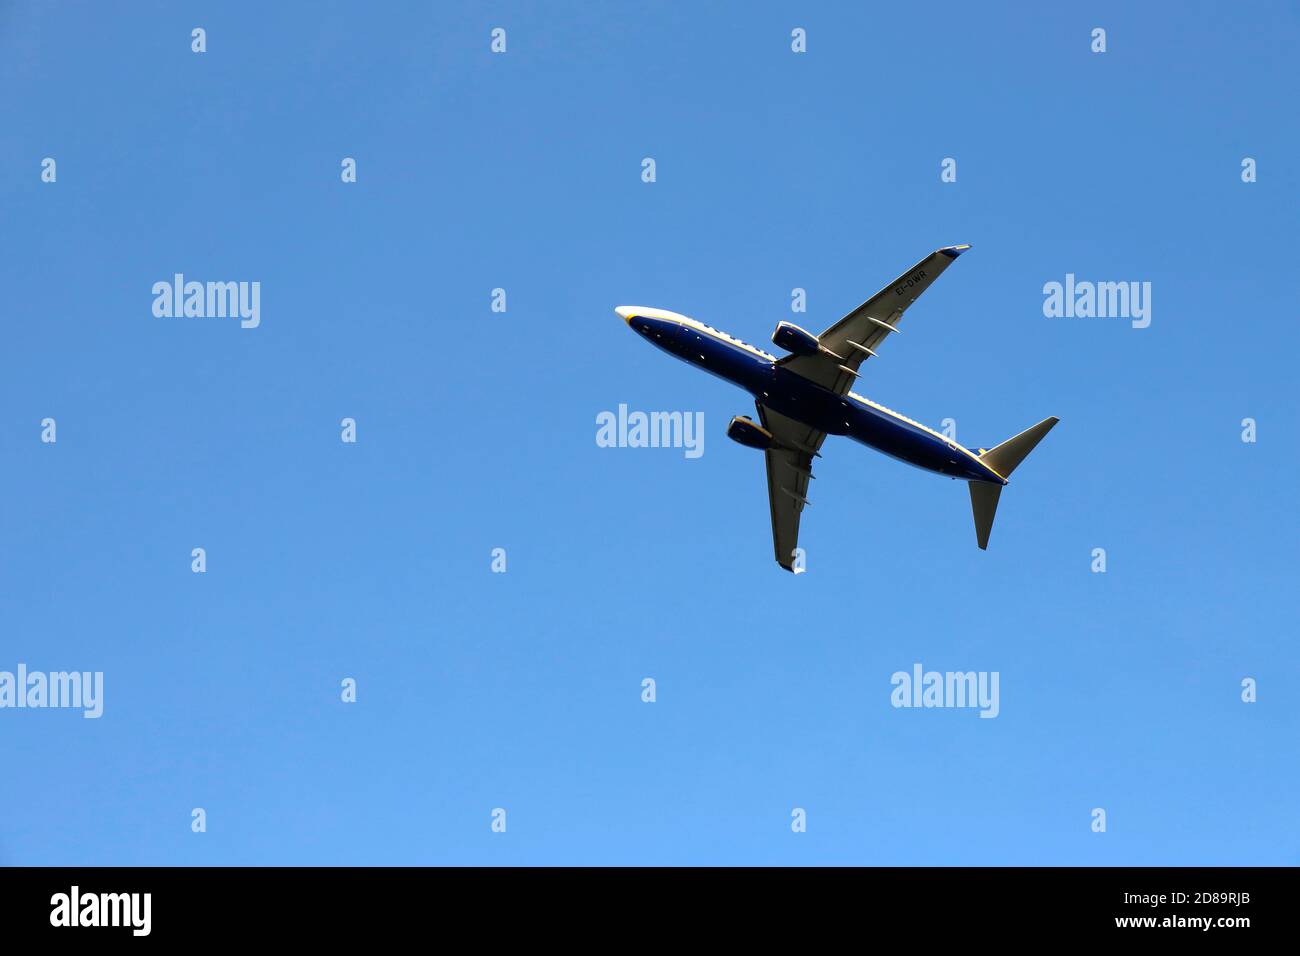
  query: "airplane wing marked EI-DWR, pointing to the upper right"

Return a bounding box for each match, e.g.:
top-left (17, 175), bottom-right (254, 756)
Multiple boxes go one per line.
top-left (777, 246), bottom-right (970, 395)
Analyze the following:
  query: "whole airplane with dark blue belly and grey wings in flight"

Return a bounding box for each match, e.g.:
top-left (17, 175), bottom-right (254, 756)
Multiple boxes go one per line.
top-left (614, 245), bottom-right (1060, 574)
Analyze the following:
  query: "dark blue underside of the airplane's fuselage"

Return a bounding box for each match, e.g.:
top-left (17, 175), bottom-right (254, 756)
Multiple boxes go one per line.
top-left (629, 316), bottom-right (1006, 484)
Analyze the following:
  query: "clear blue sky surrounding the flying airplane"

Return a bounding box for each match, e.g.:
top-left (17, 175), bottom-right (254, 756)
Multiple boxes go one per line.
top-left (0, 3), bottom-right (1300, 865)
